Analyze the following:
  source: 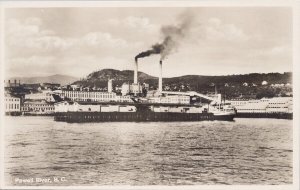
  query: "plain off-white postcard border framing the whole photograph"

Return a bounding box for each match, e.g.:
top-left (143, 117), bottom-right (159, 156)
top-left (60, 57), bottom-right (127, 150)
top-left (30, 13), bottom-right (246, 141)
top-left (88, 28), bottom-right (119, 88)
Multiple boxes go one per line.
top-left (0, 0), bottom-right (300, 190)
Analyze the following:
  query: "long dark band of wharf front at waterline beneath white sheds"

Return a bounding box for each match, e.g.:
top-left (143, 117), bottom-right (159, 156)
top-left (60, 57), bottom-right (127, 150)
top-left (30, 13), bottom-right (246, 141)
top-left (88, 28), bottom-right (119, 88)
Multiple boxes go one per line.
top-left (54, 112), bottom-right (225, 123)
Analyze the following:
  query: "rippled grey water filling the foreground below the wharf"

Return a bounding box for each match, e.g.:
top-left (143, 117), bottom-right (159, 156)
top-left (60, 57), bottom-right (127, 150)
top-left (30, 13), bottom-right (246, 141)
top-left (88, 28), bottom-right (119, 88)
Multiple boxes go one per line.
top-left (5, 117), bottom-right (293, 186)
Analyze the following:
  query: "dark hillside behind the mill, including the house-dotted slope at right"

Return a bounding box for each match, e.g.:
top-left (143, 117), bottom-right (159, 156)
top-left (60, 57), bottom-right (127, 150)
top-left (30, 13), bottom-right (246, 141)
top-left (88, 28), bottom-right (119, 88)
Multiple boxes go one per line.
top-left (74, 69), bottom-right (292, 98)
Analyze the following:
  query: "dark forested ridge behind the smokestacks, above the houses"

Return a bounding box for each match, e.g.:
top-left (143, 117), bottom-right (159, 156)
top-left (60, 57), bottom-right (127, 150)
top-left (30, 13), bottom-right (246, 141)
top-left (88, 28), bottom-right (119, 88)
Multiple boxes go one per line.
top-left (74, 69), bottom-right (292, 88)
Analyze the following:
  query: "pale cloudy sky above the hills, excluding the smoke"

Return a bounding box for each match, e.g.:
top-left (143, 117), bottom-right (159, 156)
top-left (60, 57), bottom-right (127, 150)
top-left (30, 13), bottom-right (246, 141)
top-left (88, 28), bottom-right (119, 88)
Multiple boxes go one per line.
top-left (4, 7), bottom-right (293, 78)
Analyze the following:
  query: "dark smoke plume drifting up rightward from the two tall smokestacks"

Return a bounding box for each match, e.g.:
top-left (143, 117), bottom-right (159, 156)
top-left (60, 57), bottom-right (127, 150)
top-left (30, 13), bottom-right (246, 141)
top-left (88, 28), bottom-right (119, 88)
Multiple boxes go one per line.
top-left (135, 12), bottom-right (193, 61)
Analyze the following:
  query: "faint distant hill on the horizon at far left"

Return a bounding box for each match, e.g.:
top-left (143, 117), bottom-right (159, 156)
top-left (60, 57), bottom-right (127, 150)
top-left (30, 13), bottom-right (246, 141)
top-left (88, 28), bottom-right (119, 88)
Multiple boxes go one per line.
top-left (9, 74), bottom-right (78, 85)
